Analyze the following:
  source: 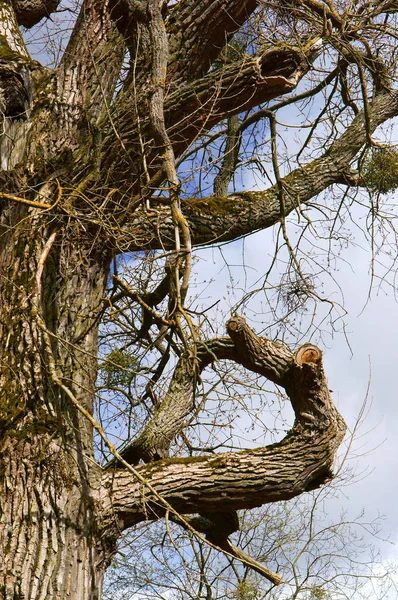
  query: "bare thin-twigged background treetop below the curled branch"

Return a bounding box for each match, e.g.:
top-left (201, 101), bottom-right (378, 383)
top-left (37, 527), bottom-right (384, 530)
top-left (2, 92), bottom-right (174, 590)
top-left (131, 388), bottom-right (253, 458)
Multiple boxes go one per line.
top-left (104, 492), bottom-right (396, 600)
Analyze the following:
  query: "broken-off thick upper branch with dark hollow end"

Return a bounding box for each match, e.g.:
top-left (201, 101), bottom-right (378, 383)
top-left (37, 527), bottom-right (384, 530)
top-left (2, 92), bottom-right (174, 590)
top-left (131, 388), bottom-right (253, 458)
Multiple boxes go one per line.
top-left (165, 38), bottom-right (322, 138)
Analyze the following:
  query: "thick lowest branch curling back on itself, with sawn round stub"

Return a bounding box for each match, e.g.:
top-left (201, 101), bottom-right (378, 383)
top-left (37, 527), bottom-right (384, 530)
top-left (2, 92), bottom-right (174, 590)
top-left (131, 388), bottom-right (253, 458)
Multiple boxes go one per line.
top-left (99, 317), bottom-right (345, 527)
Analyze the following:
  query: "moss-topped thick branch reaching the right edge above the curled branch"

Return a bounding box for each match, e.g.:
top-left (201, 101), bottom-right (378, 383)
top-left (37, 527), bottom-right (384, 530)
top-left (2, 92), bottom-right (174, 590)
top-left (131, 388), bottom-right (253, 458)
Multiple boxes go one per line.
top-left (125, 91), bottom-right (398, 249)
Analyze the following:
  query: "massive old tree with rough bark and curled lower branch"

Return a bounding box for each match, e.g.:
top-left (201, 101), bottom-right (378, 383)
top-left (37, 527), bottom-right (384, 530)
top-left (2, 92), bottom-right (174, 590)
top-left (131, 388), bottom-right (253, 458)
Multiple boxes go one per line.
top-left (0, 0), bottom-right (398, 600)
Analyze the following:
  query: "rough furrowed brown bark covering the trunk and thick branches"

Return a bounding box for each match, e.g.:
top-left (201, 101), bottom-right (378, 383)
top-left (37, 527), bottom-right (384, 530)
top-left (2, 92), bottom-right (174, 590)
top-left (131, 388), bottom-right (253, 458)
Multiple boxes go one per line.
top-left (0, 0), bottom-right (398, 600)
